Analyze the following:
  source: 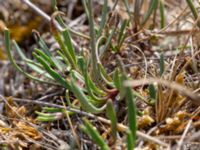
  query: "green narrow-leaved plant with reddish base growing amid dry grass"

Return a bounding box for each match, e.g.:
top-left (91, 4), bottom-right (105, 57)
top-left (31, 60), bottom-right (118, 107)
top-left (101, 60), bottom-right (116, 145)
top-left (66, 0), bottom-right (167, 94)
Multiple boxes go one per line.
top-left (4, 0), bottom-right (175, 150)
